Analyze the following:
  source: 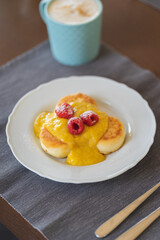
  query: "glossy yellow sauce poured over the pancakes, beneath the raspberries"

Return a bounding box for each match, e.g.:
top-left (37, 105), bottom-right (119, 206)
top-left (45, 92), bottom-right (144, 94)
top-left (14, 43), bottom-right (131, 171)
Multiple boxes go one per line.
top-left (34, 101), bottom-right (108, 166)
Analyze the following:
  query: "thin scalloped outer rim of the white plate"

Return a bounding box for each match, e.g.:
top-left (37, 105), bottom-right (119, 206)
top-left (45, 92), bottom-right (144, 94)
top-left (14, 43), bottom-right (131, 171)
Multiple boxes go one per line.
top-left (6, 75), bottom-right (156, 184)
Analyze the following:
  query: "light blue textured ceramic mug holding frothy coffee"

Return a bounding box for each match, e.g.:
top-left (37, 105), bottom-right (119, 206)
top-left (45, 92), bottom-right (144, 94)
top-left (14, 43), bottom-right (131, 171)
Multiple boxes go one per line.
top-left (39, 0), bottom-right (103, 66)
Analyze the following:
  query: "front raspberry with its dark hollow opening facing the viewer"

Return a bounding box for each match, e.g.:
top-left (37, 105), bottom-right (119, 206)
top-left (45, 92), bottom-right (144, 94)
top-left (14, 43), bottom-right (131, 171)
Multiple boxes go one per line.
top-left (67, 117), bottom-right (84, 135)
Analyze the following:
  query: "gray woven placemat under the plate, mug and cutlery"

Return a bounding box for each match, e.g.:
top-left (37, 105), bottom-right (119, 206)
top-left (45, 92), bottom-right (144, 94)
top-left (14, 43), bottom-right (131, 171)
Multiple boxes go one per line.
top-left (0, 42), bottom-right (160, 240)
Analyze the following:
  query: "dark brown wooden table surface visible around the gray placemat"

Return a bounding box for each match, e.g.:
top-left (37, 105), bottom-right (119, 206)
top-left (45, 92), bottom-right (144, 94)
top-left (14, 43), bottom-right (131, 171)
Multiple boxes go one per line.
top-left (0, 0), bottom-right (160, 240)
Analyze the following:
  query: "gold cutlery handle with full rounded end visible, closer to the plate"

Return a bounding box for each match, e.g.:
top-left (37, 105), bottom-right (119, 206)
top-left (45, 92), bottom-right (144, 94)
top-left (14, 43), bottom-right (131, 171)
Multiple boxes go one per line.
top-left (95, 182), bottom-right (160, 238)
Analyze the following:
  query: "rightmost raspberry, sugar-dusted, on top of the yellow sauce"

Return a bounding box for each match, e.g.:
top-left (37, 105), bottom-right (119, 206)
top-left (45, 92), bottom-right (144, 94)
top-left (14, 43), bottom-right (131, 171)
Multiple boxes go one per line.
top-left (80, 111), bottom-right (99, 126)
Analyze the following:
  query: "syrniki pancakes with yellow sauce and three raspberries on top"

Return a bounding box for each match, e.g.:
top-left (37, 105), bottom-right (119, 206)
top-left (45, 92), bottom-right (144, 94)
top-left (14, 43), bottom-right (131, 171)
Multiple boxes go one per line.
top-left (34, 93), bottom-right (125, 166)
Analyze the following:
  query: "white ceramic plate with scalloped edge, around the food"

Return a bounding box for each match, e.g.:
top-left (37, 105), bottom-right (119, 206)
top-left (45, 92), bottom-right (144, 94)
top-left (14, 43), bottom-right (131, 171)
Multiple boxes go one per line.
top-left (6, 76), bottom-right (156, 183)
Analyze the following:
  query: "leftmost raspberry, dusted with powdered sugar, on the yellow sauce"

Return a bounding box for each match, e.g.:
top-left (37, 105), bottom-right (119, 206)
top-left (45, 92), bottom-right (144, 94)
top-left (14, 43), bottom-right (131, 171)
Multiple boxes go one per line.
top-left (55, 103), bottom-right (74, 119)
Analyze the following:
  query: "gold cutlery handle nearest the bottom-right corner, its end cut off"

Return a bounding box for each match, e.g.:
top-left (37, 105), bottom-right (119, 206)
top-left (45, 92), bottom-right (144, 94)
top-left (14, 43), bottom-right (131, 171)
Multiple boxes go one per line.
top-left (116, 208), bottom-right (160, 240)
